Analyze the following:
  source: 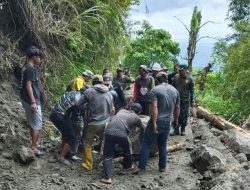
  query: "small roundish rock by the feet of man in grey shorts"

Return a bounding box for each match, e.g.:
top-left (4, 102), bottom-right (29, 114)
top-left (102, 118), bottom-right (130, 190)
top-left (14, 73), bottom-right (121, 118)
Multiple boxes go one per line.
top-left (17, 146), bottom-right (35, 164)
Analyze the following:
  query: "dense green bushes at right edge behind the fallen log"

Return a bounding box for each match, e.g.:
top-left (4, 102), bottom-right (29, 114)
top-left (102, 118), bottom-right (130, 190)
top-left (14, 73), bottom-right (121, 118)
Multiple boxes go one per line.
top-left (201, 23), bottom-right (250, 123)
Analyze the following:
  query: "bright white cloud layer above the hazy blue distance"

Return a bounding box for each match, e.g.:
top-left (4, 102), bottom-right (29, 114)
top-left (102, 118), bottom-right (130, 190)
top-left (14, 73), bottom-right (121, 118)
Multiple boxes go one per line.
top-left (130, 0), bottom-right (231, 41)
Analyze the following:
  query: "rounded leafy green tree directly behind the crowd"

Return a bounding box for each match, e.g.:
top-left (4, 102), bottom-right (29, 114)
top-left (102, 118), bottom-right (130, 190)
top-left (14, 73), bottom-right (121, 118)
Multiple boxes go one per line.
top-left (124, 21), bottom-right (180, 71)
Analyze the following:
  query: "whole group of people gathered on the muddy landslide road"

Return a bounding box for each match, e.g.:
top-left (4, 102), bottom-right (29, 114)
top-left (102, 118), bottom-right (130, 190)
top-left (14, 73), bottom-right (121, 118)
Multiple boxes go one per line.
top-left (20, 46), bottom-right (194, 184)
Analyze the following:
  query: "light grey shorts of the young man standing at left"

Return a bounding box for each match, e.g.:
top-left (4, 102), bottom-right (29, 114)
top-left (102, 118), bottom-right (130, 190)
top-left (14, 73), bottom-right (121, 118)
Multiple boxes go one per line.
top-left (22, 100), bottom-right (42, 130)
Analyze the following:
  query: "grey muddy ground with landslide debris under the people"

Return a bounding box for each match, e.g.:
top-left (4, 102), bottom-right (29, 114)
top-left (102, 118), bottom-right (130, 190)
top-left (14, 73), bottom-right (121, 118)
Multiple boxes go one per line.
top-left (0, 78), bottom-right (250, 190)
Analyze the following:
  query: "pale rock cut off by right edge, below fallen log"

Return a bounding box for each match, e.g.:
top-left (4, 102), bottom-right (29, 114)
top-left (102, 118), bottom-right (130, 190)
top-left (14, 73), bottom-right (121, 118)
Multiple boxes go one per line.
top-left (224, 129), bottom-right (250, 160)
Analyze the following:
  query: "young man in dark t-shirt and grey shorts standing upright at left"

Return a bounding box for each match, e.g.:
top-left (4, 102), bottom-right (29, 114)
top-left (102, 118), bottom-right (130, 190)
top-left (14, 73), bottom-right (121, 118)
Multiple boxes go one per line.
top-left (20, 46), bottom-right (44, 156)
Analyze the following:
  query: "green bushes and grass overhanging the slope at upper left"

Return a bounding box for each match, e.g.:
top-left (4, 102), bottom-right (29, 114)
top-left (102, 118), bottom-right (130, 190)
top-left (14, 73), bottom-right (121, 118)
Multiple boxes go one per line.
top-left (33, 0), bottom-right (139, 96)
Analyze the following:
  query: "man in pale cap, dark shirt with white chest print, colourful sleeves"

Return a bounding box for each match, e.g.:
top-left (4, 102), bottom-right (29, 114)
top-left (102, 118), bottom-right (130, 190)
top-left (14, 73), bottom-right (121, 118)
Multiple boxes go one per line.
top-left (132, 65), bottom-right (155, 115)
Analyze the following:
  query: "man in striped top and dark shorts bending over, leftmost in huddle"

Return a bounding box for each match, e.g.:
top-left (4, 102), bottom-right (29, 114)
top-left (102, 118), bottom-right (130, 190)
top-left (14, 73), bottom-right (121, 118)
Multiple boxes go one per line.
top-left (50, 91), bottom-right (82, 165)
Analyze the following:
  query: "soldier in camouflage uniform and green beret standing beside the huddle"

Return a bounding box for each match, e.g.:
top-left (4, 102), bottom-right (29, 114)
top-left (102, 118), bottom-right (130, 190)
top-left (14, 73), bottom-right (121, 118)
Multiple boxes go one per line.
top-left (171, 64), bottom-right (194, 136)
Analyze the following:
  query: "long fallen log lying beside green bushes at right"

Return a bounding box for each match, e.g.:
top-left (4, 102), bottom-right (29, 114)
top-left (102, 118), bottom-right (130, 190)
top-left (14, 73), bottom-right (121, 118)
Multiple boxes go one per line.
top-left (196, 106), bottom-right (250, 134)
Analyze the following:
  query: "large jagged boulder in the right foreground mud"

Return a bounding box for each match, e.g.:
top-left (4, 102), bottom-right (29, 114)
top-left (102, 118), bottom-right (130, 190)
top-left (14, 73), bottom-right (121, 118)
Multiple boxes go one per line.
top-left (190, 145), bottom-right (226, 173)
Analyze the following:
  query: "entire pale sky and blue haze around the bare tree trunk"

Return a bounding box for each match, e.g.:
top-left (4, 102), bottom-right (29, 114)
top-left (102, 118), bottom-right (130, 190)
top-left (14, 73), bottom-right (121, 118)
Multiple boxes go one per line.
top-left (129, 0), bottom-right (231, 68)
